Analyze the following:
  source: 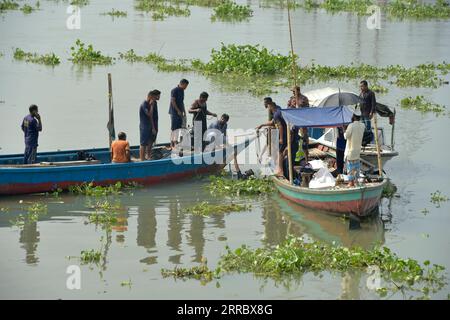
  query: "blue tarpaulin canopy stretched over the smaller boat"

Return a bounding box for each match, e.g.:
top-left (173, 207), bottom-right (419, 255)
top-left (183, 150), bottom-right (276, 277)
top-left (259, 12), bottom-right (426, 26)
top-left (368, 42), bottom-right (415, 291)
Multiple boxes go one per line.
top-left (281, 106), bottom-right (353, 128)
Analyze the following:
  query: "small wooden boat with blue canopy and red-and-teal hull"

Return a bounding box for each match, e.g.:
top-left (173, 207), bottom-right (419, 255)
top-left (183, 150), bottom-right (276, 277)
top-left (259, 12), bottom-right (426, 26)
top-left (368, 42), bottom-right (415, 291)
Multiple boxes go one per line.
top-left (273, 106), bottom-right (387, 216)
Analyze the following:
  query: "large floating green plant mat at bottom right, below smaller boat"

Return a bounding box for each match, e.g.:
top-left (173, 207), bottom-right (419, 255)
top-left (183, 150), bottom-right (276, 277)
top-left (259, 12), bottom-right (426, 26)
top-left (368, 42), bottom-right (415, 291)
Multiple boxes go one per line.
top-left (217, 237), bottom-right (447, 298)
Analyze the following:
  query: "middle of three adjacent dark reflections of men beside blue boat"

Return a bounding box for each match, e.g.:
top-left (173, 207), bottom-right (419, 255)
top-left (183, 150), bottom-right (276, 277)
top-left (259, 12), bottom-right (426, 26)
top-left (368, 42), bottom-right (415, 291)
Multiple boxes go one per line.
top-left (167, 201), bottom-right (183, 264)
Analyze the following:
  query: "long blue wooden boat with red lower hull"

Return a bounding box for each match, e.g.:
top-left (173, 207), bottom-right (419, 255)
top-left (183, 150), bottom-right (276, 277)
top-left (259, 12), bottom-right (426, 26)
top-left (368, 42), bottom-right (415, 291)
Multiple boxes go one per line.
top-left (0, 138), bottom-right (252, 195)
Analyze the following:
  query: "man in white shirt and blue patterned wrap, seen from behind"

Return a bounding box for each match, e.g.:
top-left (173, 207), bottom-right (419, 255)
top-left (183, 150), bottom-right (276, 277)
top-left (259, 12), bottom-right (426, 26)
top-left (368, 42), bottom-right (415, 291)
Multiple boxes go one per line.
top-left (344, 109), bottom-right (365, 187)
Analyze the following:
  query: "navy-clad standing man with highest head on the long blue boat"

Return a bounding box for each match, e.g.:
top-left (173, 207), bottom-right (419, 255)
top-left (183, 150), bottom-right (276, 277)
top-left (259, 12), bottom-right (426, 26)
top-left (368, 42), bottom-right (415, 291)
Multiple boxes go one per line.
top-left (169, 79), bottom-right (189, 147)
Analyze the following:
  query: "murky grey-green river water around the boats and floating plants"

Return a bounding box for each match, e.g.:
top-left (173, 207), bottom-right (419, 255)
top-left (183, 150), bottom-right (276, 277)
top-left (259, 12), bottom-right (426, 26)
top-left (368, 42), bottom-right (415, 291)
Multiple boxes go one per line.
top-left (0, 0), bottom-right (450, 299)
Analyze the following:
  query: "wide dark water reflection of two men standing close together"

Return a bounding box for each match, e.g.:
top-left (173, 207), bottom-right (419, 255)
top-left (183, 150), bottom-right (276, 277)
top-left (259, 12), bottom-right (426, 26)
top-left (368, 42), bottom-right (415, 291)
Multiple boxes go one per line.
top-left (136, 206), bottom-right (158, 265)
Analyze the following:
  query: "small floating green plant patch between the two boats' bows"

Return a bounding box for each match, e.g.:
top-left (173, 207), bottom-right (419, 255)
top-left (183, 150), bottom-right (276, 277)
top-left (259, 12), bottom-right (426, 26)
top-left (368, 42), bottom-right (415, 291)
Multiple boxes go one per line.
top-left (207, 176), bottom-right (274, 196)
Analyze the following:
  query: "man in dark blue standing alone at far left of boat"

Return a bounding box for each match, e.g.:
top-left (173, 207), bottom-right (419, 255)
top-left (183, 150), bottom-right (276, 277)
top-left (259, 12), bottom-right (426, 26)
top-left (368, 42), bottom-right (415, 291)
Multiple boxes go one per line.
top-left (21, 104), bottom-right (42, 164)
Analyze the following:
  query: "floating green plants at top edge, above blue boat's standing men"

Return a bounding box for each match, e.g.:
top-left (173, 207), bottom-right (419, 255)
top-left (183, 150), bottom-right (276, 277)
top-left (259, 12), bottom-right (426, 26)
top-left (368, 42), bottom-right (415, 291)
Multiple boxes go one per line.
top-left (135, 0), bottom-right (191, 20)
